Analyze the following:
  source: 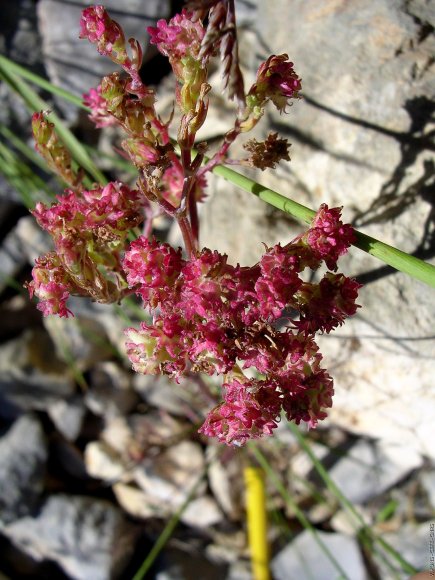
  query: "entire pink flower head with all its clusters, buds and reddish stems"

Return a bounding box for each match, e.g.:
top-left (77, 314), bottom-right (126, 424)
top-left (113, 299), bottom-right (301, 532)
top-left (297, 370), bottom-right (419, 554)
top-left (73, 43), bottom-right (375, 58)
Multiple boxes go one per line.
top-left (28, 0), bottom-right (360, 445)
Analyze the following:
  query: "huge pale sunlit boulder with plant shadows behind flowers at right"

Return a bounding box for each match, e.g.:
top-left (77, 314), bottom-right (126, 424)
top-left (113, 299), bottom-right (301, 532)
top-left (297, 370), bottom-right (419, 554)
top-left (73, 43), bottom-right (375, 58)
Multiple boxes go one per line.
top-left (201, 0), bottom-right (435, 458)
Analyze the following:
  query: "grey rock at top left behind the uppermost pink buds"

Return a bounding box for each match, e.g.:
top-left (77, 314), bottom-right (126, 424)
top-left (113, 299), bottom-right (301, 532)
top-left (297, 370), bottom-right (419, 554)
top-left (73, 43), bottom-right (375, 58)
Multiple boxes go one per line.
top-left (38, 0), bottom-right (169, 119)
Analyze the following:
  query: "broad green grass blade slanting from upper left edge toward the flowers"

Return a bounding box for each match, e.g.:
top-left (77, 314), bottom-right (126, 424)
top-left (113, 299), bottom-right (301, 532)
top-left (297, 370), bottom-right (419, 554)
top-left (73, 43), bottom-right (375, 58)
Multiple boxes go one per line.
top-left (0, 66), bottom-right (107, 184)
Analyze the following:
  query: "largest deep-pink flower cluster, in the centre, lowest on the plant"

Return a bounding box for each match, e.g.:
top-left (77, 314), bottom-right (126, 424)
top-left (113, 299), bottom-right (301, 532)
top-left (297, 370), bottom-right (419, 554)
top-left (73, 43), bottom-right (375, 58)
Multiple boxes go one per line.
top-left (123, 205), bottom-right (359, 444)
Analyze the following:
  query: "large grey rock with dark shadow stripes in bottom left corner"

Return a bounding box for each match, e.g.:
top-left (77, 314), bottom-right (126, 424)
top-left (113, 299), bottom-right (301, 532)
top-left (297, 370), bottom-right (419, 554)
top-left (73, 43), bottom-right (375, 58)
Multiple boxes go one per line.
top-left (6, 495), bottom-right (134, 580)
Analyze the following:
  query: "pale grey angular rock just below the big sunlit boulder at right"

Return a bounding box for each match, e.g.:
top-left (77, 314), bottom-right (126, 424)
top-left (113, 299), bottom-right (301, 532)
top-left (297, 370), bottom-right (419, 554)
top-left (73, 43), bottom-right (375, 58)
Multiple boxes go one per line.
top-left (329, 440), bottom-right (423, 504)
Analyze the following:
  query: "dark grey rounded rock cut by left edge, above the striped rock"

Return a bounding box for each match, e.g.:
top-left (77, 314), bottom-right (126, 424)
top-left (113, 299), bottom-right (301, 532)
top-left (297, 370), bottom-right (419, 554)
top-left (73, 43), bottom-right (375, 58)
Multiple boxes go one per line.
top-left (0, 415), bottom-right (48, 527)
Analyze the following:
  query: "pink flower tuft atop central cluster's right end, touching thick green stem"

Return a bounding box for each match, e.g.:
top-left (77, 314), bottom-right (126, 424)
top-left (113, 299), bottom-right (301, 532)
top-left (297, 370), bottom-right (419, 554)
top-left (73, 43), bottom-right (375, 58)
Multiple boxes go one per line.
top-left (302, 203), bottom-right (356, 271)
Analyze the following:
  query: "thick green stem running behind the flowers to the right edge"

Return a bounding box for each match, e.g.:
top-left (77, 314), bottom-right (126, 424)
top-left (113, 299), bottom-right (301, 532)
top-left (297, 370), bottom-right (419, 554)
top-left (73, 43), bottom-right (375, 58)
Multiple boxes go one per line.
top-left (213, 165), bottom-right (435, 288)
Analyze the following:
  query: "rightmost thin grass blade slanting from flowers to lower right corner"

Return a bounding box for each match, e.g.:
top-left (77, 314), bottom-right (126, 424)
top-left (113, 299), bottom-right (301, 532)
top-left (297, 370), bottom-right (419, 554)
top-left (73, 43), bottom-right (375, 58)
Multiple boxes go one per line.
top-left (287, 422), bottom-right (418, 574)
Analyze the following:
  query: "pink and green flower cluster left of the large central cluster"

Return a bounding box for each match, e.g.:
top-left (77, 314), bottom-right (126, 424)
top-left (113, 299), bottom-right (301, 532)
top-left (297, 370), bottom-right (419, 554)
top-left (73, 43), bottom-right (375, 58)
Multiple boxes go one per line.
top-left (28, 182), bottom-right (147, 316)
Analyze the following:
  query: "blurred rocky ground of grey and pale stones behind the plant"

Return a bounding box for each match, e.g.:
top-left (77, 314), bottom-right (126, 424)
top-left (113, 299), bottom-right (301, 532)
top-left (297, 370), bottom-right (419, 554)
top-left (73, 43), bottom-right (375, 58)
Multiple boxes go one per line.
top-left (0, 0), bottom-right (435, 580)
